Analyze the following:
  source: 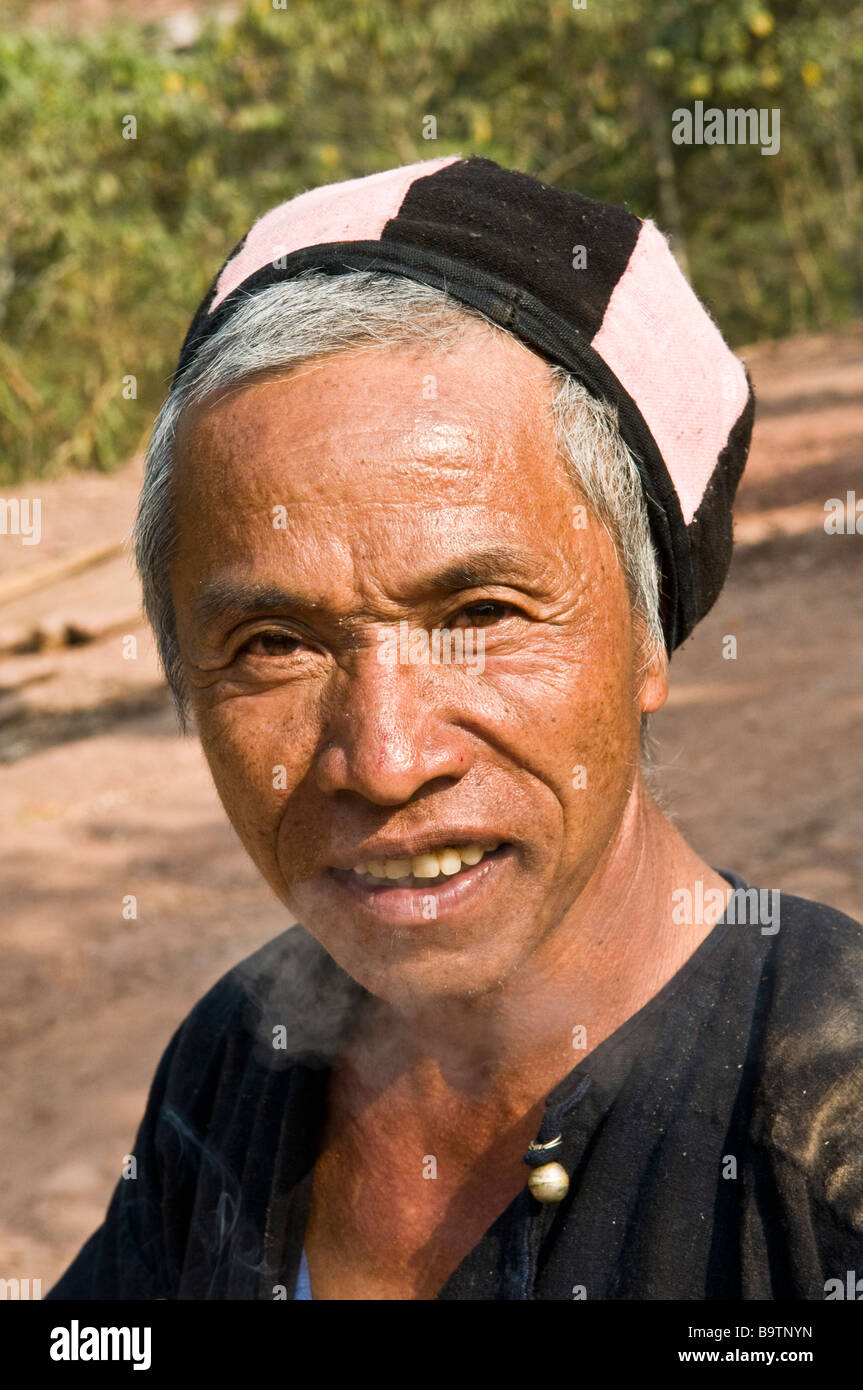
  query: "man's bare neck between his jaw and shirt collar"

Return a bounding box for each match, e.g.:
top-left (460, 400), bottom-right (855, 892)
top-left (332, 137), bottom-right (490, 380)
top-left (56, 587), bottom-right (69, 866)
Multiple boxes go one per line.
top-left (346, 780), bottom-right (731, 1098)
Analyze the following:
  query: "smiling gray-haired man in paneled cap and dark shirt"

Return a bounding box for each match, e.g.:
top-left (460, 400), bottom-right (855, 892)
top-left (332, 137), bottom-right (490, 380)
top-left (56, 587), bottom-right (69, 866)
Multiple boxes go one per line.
top-left (50, 157), bottom-right (863, 1300)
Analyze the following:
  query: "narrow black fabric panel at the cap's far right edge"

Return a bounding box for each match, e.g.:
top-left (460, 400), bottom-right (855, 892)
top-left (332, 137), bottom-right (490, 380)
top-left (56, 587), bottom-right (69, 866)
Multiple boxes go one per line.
top-left (688, 373), bottom-right (755, 621)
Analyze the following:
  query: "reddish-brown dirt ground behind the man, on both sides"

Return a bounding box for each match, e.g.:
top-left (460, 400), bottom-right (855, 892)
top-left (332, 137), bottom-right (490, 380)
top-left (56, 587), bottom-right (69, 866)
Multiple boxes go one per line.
top-left (0, 324), bottom-right (863, 1291)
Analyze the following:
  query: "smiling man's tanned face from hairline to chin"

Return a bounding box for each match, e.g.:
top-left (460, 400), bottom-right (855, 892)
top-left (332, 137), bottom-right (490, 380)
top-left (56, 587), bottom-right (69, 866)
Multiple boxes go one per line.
top-left (171, 328), bottom-right (664, 999)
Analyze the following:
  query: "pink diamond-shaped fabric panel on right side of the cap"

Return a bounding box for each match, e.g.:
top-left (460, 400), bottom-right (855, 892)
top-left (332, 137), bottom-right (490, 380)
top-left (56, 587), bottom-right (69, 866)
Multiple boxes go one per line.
top-left (592, 222), bottom-right (749, 525)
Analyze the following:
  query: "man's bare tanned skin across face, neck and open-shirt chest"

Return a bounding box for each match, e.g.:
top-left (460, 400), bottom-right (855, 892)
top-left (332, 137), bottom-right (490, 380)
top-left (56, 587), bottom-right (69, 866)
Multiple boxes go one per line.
top-left (171, 328), bottom-right (727, 1297)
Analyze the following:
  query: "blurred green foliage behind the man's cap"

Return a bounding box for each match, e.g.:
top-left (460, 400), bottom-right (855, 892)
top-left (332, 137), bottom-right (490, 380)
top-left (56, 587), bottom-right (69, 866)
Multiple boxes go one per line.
top-left (0, 0), bottom-right (863, 482)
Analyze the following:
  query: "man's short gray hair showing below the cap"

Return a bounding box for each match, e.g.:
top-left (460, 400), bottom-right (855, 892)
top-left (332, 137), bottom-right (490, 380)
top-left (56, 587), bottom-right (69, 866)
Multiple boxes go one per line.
top-left (135, 271), bottom-right (664, 760)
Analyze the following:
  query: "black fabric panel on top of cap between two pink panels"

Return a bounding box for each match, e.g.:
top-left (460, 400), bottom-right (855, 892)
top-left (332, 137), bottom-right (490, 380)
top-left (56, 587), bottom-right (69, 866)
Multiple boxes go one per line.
top-left (381, 156), bottom-right (642, 338)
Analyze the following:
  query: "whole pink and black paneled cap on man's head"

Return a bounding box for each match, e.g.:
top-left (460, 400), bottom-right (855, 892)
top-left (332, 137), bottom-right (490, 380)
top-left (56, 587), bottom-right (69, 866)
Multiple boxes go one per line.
top-left (175, 156), bottom-right (755, 652)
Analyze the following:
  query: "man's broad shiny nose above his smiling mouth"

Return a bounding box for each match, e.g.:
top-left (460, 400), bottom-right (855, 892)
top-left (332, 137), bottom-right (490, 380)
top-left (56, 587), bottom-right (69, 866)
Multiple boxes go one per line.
top-left (315, 649), bottom-right (470, 806)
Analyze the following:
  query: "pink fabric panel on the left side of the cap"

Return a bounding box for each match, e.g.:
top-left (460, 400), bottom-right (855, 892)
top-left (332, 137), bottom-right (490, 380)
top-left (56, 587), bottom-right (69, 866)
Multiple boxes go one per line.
top-left (210, 154), bottom-right (461, 313)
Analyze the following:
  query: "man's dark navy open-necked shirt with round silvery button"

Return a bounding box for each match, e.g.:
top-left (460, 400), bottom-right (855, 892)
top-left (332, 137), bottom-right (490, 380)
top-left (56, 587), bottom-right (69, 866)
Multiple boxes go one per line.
top-left (49, 873), bottom-right (863, 1300)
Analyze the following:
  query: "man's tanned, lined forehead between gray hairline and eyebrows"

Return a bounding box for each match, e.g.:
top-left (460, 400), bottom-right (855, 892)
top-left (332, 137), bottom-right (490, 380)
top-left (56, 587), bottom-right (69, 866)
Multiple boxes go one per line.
top-left (175, 331), bottom-right (611, 617)
